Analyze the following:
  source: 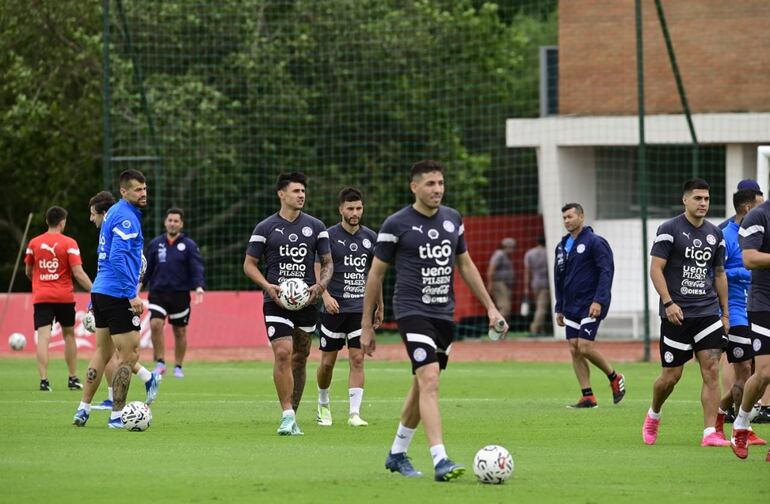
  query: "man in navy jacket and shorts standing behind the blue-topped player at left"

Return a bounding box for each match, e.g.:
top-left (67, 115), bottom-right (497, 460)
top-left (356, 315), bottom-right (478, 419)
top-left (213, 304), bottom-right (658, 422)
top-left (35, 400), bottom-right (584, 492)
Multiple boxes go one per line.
top-left (139, 208), bottom-right (205, 378)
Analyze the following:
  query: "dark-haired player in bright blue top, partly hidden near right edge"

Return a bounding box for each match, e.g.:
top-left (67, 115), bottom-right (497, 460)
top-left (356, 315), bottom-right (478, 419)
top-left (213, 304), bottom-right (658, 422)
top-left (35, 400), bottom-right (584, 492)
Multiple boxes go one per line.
top-left (715, 189), bottom-right (766, 445)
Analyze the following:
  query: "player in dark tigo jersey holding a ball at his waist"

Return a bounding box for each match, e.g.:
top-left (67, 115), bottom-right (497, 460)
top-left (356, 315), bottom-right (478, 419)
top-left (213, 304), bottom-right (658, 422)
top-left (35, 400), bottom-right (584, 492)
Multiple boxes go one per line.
top-left (243, 172), bottom-right (333, 436)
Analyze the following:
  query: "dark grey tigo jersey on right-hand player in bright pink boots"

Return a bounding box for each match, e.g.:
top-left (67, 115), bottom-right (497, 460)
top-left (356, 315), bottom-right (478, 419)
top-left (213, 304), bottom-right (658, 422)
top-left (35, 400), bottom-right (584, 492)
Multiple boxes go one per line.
top-left (650, 214), bottom-right (725, 318)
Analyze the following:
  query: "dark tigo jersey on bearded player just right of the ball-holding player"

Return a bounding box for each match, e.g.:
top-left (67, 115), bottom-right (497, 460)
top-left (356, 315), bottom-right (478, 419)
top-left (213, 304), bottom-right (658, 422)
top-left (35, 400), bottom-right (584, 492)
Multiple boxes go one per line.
top-left (320, 224), bottom-right (377, 313)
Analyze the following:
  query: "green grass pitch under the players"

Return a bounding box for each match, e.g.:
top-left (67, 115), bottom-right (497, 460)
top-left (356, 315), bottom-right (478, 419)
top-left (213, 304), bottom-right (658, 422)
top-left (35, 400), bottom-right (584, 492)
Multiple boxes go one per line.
top-left (0, 359), bottom-right (770, 504)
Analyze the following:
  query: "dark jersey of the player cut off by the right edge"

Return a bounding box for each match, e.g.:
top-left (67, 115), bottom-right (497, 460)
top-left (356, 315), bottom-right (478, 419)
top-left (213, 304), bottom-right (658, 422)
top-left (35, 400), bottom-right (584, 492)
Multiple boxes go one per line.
top-left (738, 200), bottom-right (770, 311)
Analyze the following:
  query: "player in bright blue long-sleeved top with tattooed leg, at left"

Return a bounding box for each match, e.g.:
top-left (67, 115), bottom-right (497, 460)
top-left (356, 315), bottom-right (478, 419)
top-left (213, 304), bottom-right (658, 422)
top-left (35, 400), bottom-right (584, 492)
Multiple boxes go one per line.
top-left (73, 170), bottom-right (153, 429)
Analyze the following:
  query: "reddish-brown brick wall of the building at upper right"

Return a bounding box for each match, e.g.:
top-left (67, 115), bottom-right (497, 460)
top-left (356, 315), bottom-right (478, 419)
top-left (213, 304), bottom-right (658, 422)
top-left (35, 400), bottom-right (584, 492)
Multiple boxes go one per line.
top-left (559, 0), bottom-right (770, 115)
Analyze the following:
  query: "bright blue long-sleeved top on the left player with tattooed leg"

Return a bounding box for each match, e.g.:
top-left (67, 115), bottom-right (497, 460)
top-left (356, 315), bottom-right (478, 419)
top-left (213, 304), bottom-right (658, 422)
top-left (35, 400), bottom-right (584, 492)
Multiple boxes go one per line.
top-left (91, 199), bottom-right (144, 299)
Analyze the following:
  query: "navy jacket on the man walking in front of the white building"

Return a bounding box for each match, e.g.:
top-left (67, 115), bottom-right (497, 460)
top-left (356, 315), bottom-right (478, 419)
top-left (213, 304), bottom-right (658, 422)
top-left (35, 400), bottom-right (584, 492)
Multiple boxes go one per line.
top-left (554, 226), bottom-right (615, 320)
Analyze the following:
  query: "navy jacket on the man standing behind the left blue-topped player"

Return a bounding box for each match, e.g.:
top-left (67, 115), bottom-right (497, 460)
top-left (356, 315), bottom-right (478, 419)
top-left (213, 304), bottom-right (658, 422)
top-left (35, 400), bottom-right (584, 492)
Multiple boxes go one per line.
top-left (143, 233), bottom-right (205, 292)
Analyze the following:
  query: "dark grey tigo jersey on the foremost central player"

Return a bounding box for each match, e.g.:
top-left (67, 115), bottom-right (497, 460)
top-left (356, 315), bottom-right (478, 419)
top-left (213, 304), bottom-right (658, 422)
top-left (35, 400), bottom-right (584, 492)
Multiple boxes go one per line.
top-left (374, 206), bottom-right (467, 320)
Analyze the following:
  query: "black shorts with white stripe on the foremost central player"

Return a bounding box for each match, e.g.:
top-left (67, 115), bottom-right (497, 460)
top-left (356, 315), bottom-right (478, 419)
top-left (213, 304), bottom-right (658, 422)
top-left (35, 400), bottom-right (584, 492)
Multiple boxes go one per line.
top-left (397, 316), bottom-right (455, 374)
